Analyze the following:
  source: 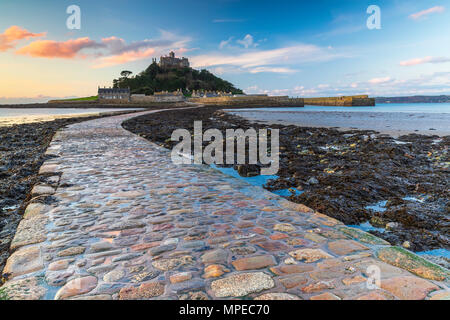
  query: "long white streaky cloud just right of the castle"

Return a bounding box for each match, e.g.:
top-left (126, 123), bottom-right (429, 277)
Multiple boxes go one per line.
top-left (190, 44), bottom-right (342, 73)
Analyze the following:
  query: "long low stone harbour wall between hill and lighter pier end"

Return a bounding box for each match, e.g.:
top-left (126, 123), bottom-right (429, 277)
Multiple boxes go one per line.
top-left (189, 96), bottom-right (304, 107)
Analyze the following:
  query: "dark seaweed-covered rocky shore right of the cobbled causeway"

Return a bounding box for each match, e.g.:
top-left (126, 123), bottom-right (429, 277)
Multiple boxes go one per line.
top-left (123, 107), bottom-right (450, 267)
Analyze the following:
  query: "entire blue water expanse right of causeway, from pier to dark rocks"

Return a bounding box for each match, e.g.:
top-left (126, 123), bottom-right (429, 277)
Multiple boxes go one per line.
top-left (227, 103), bottom-right (450, 137)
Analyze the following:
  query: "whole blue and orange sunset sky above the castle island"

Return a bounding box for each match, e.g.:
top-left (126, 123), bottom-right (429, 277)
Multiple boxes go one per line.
top-left (0, 0), bottom-right (450, 103)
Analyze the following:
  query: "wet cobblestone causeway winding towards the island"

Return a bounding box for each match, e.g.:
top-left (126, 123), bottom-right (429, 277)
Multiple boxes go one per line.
top-left (2, 112), bottom-right (449, 300)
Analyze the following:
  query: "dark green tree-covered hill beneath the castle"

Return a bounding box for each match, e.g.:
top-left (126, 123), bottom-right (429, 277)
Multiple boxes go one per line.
top-left (113, 62), bottom-right (243, 95)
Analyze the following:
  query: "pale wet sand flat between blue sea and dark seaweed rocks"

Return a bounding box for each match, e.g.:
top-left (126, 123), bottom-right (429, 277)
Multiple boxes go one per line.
top-left (230, 109), bottom-right (450, 137)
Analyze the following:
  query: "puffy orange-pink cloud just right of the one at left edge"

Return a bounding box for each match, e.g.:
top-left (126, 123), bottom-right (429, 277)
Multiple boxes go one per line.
top-left (16, 37), bottom-right (104, 59)
